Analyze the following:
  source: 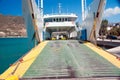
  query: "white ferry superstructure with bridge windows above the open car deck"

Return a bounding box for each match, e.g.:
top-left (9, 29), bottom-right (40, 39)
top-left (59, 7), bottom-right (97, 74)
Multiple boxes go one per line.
top-left (44, 13), bottom-right (77, 39)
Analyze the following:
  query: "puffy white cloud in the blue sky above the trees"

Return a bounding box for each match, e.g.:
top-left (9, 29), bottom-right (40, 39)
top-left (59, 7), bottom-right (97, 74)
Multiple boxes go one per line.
top-left (103, 6), bottom-right (120, 17)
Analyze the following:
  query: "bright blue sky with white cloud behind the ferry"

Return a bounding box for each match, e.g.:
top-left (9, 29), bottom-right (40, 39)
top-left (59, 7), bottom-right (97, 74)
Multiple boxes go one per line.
top-left (0, 0), bottom-right (120, 23)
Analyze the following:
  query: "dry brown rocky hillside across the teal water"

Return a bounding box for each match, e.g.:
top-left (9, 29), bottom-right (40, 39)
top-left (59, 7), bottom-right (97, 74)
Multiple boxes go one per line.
top-left (0, 14), bottom-right (26, 37)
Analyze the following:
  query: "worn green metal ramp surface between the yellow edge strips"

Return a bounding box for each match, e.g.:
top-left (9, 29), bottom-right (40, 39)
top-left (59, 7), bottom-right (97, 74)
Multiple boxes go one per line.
top-left (23, 40), bottom-right (120, 80)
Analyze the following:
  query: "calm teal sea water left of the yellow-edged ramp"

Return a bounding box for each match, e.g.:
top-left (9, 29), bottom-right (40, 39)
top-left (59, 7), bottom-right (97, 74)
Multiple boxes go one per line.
top-left (0, 38), bottom-right (34, 74)
